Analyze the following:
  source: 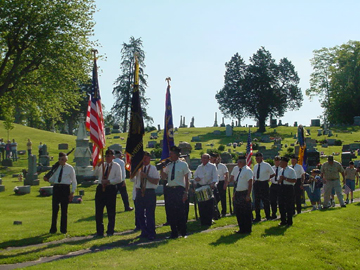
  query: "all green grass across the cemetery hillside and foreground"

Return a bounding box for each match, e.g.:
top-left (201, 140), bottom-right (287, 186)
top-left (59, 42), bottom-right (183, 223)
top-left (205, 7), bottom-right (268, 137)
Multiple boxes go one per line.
top-left (0, 122), bottom-right (360, 269)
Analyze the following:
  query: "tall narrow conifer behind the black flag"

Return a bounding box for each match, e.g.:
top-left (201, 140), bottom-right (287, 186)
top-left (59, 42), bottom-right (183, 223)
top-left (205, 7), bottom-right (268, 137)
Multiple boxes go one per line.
top-left (112, 37), bottom-right (153, 132)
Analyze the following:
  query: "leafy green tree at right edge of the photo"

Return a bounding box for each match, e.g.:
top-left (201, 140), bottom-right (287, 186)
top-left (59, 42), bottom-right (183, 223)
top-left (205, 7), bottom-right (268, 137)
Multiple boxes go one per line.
top-left (306, 41), bottom-right (360, 124)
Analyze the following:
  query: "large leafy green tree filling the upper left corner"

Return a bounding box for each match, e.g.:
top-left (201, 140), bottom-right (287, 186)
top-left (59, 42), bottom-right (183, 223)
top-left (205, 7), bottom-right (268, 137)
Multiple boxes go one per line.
top-left (0, 0), bottom-right (95, 122)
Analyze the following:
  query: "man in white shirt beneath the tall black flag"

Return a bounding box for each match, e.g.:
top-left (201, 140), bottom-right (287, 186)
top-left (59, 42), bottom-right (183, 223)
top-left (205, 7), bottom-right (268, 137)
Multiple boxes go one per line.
top-left (134, 152), bottom-right (160, 240)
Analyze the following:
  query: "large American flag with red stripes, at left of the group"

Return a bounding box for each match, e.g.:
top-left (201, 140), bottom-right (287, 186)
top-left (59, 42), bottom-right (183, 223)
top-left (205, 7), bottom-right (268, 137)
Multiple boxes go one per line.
top-left (86, 54), bottom-right (105, 168)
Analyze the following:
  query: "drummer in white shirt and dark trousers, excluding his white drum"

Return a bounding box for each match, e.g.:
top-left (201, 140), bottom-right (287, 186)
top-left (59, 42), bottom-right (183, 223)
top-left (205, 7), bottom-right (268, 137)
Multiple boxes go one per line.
top-left (194, 154), bottom-right (219, 226)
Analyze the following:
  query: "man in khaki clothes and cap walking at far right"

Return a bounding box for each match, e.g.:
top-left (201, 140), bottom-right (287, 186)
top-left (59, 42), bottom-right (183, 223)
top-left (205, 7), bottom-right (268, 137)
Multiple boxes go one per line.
top-left (321, 156), bottom-right (346, 209)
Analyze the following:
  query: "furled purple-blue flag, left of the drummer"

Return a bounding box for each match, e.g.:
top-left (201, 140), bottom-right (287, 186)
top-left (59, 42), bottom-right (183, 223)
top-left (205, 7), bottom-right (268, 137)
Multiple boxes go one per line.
top-left (161, 84), bottom-right (174, 160)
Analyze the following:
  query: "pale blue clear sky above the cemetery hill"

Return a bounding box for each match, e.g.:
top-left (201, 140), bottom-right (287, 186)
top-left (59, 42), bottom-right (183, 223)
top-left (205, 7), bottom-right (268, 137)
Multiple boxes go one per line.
top-left (93, 0), bottom-right (360, 128)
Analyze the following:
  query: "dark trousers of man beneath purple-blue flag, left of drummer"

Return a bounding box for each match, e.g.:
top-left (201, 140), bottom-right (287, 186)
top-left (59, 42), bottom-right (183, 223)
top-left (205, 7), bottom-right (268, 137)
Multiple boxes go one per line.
top-left (166, 186), bottom-right (186, 237)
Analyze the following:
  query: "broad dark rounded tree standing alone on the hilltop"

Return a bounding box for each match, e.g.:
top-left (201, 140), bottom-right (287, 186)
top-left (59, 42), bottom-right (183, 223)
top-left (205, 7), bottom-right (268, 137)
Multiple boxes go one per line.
top-left (215, 47), bottom-right (303, 132)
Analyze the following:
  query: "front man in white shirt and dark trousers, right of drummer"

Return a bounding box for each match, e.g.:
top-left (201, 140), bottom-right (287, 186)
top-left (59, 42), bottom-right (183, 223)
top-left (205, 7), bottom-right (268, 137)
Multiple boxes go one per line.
top-left (230, 156), bottom-right (253, 234)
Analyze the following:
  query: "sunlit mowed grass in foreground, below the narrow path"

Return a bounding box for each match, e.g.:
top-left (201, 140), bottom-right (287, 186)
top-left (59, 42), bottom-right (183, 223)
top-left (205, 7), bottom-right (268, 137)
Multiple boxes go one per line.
top-left (22, 203), bottom-right (360, 269)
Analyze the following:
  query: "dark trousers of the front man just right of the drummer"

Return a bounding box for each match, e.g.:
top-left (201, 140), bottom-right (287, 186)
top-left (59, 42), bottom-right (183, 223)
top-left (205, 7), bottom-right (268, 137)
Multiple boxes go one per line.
top-left (234, 190), bottom-right (252, 233)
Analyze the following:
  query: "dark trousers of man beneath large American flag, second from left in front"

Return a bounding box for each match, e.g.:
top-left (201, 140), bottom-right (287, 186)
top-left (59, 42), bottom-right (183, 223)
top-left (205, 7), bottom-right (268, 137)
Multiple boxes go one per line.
top-left (95, 185), bottom-right (117, 235)
